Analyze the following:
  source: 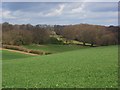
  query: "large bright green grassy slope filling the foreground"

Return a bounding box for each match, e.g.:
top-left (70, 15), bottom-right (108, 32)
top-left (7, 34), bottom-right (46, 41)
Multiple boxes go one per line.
top-left (3, 46), bottom-right (118, 88)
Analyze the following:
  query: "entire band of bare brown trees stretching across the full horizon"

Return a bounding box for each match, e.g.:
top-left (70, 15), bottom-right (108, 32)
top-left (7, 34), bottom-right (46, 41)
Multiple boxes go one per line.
top-left (2, 22), bottom-right (119, 46)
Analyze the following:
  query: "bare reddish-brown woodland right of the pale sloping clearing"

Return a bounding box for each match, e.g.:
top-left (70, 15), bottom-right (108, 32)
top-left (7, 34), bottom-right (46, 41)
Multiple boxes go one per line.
top-left (55, 24), bottom-right (119, 46)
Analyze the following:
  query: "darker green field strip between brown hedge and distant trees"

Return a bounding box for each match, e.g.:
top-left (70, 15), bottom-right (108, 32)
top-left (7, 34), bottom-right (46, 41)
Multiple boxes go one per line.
top-left (24, 44), bottom-right (88, 53)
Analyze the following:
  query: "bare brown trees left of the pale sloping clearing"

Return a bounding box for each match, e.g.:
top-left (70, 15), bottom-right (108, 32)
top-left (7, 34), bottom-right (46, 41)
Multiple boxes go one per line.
top-left (2, 22), bottom-right (50, 45)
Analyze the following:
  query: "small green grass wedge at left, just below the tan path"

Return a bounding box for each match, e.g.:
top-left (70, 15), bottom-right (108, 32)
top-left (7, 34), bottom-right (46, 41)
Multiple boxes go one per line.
top-left (2, 50), bottom-right (32, 60)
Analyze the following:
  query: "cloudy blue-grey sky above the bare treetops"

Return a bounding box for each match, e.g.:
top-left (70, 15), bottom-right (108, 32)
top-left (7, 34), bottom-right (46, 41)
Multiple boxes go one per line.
top-left (0, 2), bottom-right (118, 25)
